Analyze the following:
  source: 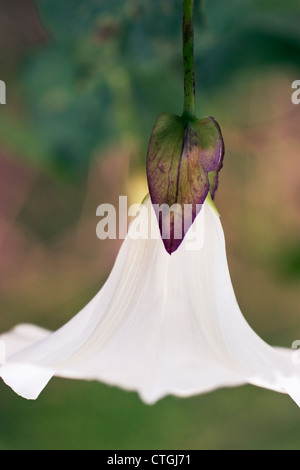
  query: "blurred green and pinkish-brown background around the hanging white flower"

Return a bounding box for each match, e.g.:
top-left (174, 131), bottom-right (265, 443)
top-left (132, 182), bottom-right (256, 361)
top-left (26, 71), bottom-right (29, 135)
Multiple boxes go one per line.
top-left (0, 0), bottom-right (300, 450)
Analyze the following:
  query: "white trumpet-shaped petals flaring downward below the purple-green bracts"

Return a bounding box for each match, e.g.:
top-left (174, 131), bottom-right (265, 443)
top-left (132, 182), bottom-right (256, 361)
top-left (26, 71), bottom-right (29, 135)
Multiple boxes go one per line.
top-left (0, 199), bottom-right (300, 405)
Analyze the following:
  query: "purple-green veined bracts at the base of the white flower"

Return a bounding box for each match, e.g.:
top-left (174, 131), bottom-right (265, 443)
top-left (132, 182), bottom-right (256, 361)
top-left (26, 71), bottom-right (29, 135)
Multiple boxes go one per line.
top-left (146, 113), bottom-right (224, 254)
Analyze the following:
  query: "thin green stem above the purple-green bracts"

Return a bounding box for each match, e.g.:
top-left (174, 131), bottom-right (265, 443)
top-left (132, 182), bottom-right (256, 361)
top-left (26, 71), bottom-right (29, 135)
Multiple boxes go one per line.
top-left (182, 0), bottom-right (195, 116)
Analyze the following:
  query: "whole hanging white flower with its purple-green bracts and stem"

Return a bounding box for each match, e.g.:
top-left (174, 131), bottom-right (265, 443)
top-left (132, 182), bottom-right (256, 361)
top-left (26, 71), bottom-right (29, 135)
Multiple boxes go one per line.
top-left (0, 0), bottom-right (300, 412)
